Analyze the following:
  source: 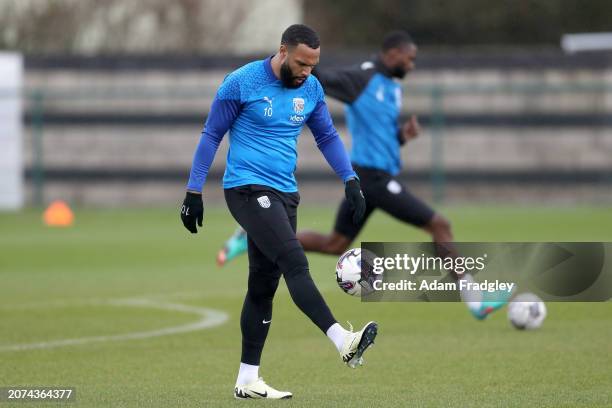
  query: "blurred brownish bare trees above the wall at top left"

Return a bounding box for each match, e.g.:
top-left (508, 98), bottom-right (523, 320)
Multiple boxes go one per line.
top-left (0, 0), bottom-right (250, 53)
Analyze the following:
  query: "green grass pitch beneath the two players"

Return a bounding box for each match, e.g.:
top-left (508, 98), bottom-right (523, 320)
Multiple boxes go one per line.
top-left (0, 206), bottom-right (612, 407)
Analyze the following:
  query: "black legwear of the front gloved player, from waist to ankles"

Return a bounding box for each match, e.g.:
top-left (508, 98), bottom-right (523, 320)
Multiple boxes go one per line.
top-left (225, 184), bottom-right (336, 365)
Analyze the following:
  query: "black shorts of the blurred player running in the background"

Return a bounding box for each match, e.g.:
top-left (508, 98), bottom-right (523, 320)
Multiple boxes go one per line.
top-left (334, 165), bottom-right (434, 240)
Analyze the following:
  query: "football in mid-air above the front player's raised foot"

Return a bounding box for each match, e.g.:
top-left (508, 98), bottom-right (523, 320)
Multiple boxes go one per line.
top-left (336, 248), bottom-right (380, 296)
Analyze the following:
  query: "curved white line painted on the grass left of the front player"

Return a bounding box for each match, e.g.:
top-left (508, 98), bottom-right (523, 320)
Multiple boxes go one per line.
top-left (0, 299), bottom-right (229, 352)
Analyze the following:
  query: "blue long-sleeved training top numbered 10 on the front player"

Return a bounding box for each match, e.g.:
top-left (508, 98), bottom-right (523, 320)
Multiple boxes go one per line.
top-left (187, 57), bottom-right (356, 192)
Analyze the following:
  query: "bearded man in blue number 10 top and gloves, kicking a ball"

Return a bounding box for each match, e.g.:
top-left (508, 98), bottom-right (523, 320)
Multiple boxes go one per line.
top-left (181, 24), bottom-right (377, 399)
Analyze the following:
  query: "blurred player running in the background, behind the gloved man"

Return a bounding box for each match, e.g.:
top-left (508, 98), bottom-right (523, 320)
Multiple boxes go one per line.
top-left (217, 30), bottom-right (506, 319)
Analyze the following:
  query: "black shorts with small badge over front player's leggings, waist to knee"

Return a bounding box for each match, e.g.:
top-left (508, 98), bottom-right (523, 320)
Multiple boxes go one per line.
top-left (224, 184), bottom-right (301, 268)
